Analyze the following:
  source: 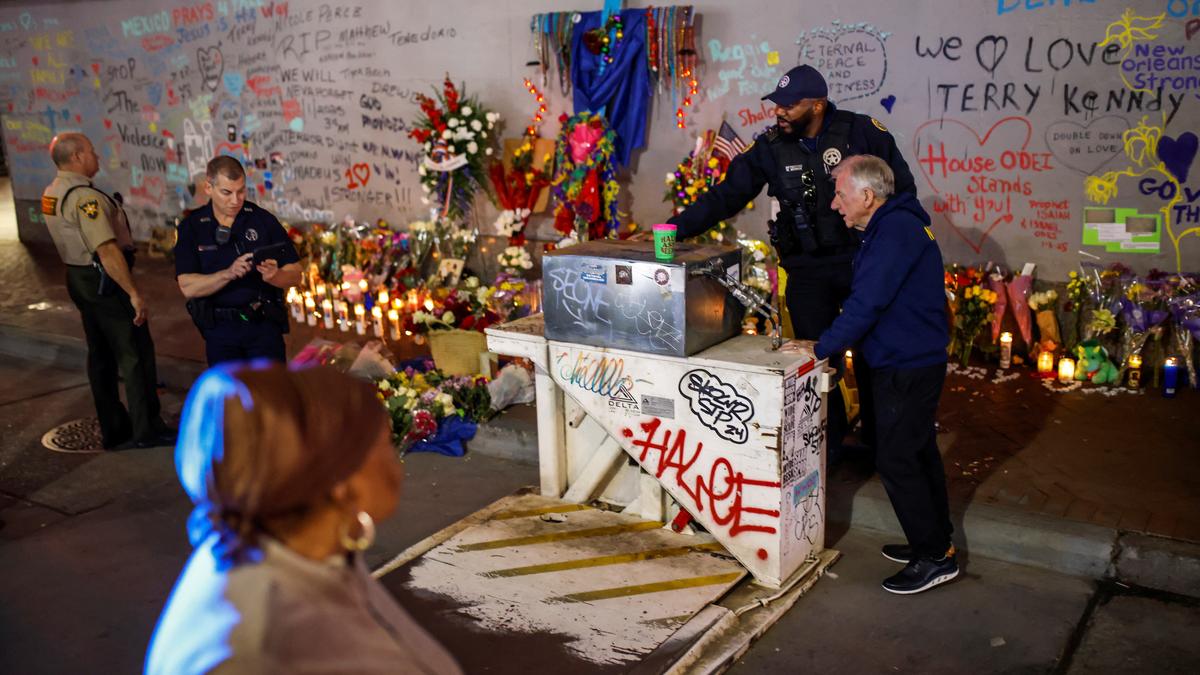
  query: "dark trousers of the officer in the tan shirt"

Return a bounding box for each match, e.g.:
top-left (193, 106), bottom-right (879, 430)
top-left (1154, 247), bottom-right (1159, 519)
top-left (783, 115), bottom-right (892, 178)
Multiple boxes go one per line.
top-left (67, 265), bottom-right (166, 448)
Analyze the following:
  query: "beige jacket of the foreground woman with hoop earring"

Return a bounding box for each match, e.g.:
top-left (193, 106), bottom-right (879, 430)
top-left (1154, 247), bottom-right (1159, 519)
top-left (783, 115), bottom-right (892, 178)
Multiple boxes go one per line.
top-left (145, 539), bottom-right (462, 675)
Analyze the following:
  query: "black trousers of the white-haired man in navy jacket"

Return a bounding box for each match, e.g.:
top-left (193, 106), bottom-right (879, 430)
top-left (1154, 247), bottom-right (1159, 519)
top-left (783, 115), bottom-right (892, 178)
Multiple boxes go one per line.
top-left (871, 364), bottom-right (954, 557)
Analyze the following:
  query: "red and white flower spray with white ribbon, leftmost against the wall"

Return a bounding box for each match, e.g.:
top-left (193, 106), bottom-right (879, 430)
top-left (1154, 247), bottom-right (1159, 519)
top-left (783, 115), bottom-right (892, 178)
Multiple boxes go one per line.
top-left (408, 76), bottom-right (499, 222)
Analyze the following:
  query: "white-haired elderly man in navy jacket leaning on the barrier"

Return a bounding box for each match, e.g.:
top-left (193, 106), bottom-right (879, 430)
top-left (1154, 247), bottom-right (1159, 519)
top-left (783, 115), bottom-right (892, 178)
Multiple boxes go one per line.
top-left (815, 155), bottom-right (959, 595)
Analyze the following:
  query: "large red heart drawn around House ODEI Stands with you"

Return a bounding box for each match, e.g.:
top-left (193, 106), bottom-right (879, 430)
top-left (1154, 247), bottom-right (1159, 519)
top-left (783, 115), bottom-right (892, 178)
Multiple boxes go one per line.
top-left (913, 117), bottom-right (1033, 253)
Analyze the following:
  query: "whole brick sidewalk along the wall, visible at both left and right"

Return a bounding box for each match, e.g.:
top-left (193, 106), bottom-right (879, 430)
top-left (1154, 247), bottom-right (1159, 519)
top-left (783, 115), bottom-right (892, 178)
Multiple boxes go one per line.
top-left (0, 241), bottom-right (1200, 542)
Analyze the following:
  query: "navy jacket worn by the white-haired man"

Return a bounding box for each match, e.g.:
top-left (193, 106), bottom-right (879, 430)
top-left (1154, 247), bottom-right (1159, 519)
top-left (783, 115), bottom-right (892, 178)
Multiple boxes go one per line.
top-left (815, 192), bottom-right (950, 369)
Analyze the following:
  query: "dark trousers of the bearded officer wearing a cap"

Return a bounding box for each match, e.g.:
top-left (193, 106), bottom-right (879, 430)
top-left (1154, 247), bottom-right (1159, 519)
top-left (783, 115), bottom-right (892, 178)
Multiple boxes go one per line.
top-left (785, 261), bottom-right (868, 451)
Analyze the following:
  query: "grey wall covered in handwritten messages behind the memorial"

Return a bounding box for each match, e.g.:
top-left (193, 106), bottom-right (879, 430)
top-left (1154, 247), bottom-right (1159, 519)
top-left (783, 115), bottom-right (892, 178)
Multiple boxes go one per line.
top-left (0, 0), bottom-right (1200, 279)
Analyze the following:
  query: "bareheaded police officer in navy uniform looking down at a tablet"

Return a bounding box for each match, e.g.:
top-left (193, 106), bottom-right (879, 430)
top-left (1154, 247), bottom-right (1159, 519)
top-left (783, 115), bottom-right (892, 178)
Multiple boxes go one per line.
top-left (175, 156), bottom-right (301, 365)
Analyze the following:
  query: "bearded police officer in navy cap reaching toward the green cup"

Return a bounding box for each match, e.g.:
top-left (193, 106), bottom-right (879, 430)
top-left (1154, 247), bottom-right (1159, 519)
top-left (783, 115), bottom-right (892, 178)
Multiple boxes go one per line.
top-left (668, 65), bottom-right (917, 454)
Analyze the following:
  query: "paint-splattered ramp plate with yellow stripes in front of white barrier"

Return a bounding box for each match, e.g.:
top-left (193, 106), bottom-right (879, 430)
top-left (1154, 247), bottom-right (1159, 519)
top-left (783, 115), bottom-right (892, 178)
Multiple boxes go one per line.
top-left (377, 494), bottom-right (836, 674)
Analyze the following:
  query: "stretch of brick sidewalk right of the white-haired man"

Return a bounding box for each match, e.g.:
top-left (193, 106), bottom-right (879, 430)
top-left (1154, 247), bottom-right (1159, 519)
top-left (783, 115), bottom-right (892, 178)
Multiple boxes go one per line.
top-left (938, 369), bottom-right (1200, 542)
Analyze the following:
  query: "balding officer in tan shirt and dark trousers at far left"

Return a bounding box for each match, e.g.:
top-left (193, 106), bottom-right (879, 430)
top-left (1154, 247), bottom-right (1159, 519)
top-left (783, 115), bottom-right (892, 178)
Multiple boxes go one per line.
top-left (42, 133), bottom-right (174, 449)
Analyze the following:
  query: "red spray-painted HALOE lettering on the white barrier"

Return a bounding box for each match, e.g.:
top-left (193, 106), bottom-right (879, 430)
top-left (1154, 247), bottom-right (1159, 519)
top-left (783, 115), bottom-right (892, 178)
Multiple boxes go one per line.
top-left (622, 418), bottom-right (780, 537)
